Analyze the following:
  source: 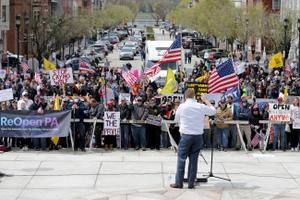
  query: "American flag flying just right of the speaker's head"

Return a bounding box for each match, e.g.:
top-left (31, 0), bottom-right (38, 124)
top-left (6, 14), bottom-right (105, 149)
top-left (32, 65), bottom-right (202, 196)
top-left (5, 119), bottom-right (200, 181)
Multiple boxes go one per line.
top-left (208, 59), bottom-right (239, 93)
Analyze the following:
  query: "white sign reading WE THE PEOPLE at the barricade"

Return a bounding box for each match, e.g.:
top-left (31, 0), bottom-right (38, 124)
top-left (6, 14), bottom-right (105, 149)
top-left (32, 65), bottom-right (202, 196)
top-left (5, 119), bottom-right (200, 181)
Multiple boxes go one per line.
top-left (103, 112), bottom-right (120, 135)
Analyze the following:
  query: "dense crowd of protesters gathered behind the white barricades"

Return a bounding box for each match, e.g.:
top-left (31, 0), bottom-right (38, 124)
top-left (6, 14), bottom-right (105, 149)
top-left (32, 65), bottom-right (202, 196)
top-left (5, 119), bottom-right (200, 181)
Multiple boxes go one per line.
top-left (0, 30), bottom-right (300, 151)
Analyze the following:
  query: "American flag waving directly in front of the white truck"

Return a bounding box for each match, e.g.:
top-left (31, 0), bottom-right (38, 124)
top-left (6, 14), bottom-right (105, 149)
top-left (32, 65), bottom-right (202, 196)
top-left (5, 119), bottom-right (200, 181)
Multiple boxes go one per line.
top-left (144, 37), bottom-right (181, 77)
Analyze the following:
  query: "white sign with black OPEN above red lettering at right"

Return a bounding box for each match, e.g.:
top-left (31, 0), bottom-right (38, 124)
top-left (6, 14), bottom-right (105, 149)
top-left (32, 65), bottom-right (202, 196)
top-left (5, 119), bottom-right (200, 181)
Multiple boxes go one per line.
top-left (269, 103), bottom-right (291, 122)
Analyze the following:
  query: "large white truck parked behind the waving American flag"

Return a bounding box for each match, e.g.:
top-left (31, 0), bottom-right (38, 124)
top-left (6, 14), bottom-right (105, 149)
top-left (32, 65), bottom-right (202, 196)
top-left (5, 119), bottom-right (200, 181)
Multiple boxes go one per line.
top-left (145, 40), bottom-right (179, 85)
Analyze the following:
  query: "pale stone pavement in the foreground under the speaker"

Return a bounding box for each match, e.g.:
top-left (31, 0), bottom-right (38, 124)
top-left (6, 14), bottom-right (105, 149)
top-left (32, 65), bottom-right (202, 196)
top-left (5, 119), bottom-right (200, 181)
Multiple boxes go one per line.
top-left (0, 150), bottom-right (300, 200)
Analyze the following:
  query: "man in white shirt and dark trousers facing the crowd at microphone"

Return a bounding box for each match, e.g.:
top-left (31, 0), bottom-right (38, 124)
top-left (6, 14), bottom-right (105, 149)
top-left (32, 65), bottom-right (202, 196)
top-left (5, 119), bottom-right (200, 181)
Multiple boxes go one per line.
top-left (170, 89), bottom-right (216, 189)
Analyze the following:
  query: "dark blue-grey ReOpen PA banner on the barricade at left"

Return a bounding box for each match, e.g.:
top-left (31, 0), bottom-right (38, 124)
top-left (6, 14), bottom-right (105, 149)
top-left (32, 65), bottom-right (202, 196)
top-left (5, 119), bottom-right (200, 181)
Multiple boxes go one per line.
top-left (0, 111), bottom-right (71, 138)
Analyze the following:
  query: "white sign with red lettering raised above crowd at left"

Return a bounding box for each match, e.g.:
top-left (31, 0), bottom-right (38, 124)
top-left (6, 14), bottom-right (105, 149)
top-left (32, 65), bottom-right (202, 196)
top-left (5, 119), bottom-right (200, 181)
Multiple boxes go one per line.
top-left (49, 67), bottom-right (74, 85)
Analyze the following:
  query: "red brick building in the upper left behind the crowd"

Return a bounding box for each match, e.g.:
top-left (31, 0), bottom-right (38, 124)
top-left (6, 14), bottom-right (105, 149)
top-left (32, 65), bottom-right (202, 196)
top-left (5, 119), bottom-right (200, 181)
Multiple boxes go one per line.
top-left (0, 0), bottom-right (93, 58)
